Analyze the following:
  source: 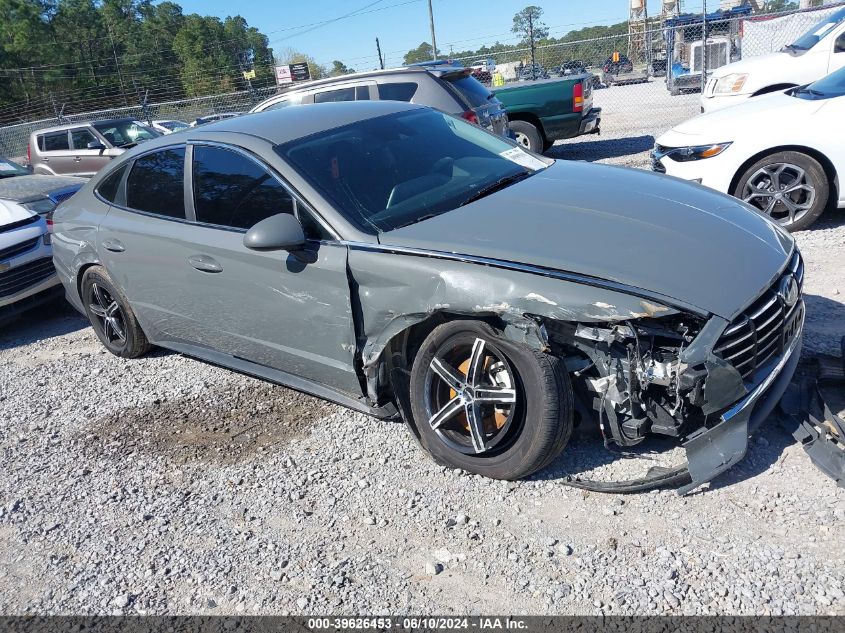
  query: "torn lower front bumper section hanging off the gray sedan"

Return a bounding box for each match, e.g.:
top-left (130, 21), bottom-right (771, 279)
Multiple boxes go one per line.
top-left (678, 308), bottom-right (804, 494)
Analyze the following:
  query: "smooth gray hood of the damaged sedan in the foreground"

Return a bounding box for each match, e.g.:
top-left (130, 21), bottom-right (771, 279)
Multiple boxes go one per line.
top-left (380, 161), bottom-right (794, 319)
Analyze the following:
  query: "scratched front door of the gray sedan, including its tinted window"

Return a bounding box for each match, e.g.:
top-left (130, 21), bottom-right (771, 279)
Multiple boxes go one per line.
top-left (178, 143), bottom-right (361, 395)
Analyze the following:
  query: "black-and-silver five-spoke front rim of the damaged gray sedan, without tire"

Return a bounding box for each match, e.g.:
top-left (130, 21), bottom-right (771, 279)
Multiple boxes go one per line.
top-left (425, 338), bottom-right (517, 454)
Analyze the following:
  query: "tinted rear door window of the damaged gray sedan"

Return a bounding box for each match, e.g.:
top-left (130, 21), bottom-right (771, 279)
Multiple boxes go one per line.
top-left (126, 147), bottom-right (185, 220)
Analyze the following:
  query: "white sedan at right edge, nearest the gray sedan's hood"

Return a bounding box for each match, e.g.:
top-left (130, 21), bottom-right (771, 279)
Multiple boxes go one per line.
top-left (652, 68), bottom-right (845, 231)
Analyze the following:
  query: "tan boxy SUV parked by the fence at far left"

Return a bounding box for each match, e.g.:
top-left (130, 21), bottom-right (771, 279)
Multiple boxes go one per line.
top-left (26, 118), bottom-right (161, 177)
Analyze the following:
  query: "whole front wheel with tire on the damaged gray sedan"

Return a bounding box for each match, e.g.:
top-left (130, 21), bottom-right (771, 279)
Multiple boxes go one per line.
top-left (410, 321), bottom-right (573, 479)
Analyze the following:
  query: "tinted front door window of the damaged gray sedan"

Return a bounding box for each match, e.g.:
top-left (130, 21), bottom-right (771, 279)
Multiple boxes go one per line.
top-left (193, 145), bottom-right (294, 229)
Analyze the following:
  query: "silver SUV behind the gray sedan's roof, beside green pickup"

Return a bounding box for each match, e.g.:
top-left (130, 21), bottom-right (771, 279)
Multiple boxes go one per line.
top-left (250, 62), bottom-right (510, 137)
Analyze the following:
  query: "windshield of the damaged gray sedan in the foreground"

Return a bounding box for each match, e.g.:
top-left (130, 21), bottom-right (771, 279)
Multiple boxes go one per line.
top-left (276, 106), bottom-right (551, 234)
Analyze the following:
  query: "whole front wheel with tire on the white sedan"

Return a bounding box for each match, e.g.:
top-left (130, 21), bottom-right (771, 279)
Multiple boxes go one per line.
top-left (733, 152), bottom-right (830, 232)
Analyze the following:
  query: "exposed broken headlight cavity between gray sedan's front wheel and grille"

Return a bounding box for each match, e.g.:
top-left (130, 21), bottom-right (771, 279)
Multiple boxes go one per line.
top-left (545, 314), bottom-right (707, 446)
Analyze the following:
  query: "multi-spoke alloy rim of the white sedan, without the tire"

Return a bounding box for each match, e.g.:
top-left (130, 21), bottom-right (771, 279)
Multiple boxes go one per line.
top-left (742, 163), bottom-right (816, 226)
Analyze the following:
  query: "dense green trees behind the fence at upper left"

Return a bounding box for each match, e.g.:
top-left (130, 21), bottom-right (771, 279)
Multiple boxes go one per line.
top-left (0, 0), bottom-right (312, 125)
